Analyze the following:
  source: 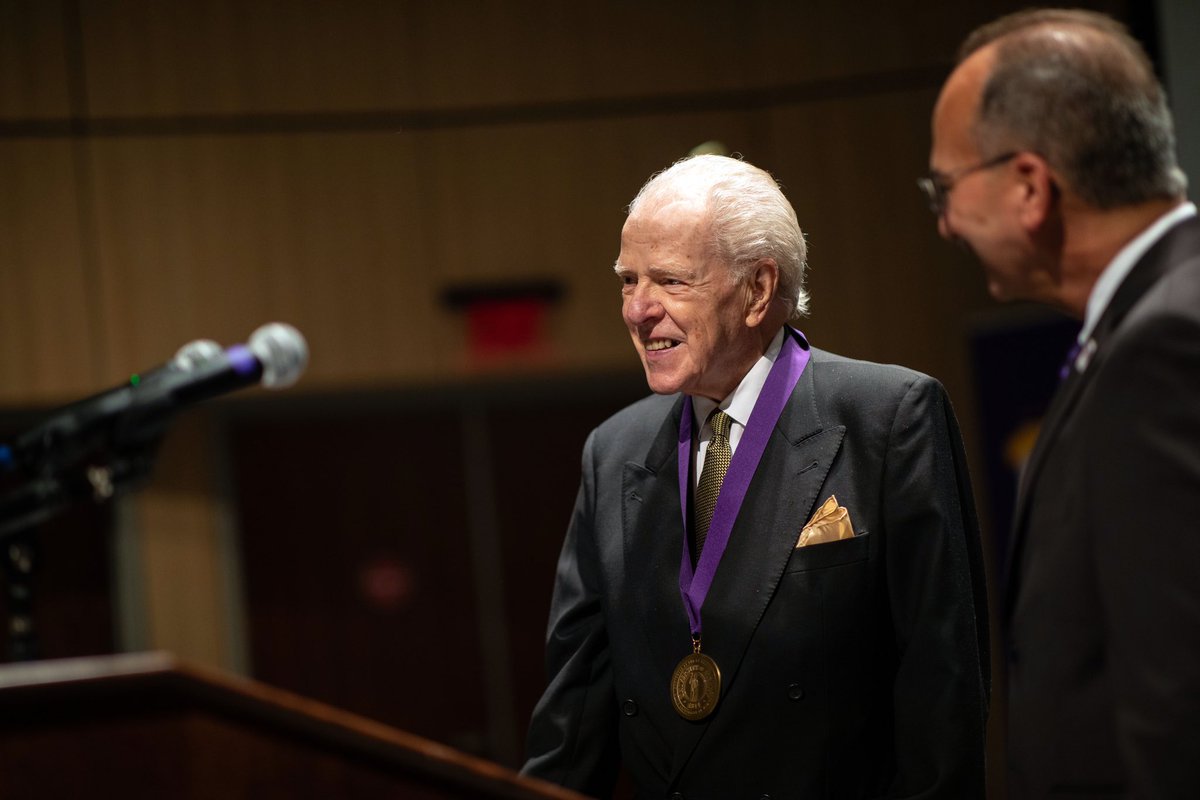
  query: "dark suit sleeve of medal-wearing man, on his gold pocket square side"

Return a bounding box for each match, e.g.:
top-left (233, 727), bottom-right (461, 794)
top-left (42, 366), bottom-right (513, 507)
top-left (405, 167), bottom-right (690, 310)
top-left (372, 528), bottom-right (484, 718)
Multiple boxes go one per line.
top-left (882, 377), bottom-right (990, 800)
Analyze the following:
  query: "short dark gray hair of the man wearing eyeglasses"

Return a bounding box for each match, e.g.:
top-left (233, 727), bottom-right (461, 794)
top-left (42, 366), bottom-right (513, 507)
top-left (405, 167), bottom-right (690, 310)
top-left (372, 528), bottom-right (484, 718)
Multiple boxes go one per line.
top-left (959, 8), bottom-right (1188, 209)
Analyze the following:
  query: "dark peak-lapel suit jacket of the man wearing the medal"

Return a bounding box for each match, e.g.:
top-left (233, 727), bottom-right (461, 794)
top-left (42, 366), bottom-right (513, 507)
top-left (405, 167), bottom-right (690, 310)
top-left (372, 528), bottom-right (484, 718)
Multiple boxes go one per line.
top-left (526, 338), bottom-right (989, 800)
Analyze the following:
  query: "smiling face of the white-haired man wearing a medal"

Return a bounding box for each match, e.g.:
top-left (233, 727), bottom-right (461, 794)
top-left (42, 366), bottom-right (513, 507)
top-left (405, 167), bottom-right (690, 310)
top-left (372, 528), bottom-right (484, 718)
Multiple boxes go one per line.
top-left (617, 199), bottom-right (761, 401)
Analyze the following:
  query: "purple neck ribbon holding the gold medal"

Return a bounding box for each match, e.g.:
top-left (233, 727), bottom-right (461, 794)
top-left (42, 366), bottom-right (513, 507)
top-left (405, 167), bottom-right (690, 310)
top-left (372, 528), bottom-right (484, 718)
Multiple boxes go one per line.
top-left (678, 327), bottom-right (810, 639)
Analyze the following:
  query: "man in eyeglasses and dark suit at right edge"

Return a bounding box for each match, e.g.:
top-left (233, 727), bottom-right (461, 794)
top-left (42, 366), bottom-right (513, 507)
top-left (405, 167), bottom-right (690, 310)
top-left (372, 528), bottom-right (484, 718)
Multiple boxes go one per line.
top-left (920, 10), bottom-right (1200, 798)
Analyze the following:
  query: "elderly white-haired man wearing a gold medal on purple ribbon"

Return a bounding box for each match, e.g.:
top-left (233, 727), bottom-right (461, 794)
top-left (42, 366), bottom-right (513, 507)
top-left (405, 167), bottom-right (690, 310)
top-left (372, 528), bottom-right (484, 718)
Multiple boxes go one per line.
top-left (524, 156), bottom-right (989, 800)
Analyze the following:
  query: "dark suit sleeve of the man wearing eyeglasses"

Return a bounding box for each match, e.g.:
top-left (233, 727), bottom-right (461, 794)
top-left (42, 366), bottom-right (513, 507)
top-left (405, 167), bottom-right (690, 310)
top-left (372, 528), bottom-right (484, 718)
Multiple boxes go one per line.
top-left (1094, 307), bottom-right (1200, 798)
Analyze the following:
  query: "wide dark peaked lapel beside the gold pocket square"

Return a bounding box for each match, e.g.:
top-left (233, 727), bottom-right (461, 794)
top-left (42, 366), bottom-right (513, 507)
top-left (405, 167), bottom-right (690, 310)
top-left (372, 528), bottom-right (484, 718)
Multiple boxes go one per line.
top-left (671, 352), bottom-right (846, 783)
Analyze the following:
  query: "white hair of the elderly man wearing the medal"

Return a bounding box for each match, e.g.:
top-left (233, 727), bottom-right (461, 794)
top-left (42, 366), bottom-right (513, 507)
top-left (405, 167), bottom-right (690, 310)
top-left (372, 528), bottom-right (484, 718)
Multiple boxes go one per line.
top-left (629, 155), bottom-right (809, 320)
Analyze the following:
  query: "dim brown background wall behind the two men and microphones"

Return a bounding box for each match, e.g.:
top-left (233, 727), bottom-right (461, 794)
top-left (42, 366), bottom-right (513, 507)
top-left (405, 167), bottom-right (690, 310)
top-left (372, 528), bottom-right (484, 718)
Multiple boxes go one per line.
top-left (7, 0), bottom-right (1180, 796)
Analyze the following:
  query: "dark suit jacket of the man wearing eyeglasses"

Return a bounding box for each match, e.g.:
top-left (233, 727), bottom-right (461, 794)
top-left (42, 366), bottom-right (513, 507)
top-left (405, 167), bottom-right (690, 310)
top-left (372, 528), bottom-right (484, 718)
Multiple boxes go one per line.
top-left (1006, 214), bottom-right (1200, 800)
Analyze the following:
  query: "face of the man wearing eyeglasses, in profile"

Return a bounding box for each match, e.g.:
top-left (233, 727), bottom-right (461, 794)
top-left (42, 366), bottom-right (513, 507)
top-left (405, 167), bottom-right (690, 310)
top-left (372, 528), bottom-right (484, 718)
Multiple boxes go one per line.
top-left (929, 48), bottom-right (1033, 300)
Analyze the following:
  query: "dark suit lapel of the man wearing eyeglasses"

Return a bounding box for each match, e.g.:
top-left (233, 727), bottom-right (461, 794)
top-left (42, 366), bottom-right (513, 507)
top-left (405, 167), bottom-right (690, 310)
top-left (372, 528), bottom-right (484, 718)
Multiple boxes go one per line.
top-left (1004, 217), bottom-right (1200, 616)
